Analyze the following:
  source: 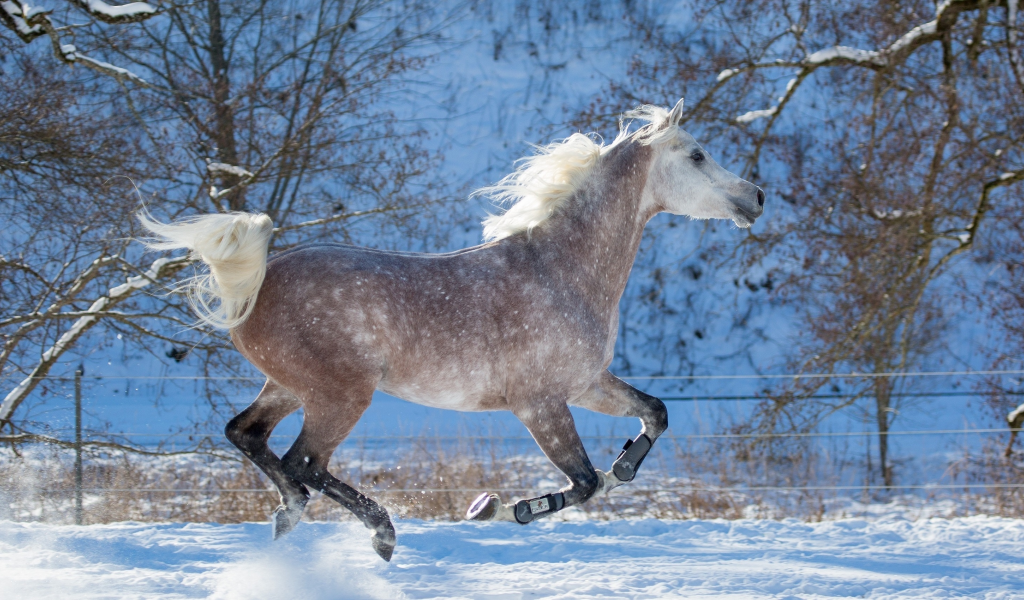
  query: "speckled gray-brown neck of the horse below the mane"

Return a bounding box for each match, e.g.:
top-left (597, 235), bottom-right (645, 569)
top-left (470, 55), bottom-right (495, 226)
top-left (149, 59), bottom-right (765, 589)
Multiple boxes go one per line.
top-left (546, 142), bottom-right (653, 310)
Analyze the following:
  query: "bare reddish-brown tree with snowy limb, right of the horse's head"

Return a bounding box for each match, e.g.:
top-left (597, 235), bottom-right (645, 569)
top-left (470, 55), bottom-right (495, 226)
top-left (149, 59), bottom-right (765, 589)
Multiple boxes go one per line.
top-left (585, 0), bottom-right (1024, 485)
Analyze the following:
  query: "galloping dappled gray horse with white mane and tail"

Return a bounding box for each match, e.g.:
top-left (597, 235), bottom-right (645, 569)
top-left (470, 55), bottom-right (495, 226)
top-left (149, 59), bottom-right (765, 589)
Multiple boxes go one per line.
top-left (139, 100), bottom-right (765, 560)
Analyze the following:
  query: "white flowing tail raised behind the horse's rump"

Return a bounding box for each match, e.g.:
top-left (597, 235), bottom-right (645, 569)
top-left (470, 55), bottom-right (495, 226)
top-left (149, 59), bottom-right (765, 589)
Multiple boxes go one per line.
top-left (138, 211), bottom-right (273, 329)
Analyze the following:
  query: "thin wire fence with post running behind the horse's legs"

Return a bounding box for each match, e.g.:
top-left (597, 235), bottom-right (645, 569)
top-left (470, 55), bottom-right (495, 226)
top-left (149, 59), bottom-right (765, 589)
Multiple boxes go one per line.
top-left (0, 370), bottom-right (1024, 518)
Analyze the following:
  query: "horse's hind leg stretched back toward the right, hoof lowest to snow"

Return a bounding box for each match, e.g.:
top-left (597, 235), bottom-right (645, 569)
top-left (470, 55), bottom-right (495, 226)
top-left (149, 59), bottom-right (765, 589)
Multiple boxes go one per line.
top-left (282, 386), bottom-right (396, 561)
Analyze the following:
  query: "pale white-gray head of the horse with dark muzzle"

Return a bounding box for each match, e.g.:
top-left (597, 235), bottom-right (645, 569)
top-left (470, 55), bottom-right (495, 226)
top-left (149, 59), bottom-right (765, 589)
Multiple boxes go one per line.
top-left (644, 100), bottom-right (765, 227)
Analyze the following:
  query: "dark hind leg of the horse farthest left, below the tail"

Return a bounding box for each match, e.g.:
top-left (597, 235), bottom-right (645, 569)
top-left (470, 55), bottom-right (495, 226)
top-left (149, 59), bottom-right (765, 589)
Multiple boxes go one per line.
top-left (224, 380), bottom-right (309, 540)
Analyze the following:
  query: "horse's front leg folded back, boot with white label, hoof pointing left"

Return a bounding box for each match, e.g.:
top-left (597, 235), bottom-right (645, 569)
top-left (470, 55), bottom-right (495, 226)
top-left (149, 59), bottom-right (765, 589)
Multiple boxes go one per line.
top-left (466, 400), bottom-right (601, 525)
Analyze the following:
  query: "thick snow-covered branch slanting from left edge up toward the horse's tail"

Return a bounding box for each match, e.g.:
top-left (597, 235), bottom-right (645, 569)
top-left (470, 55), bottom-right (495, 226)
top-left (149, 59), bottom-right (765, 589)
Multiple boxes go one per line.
top-left (0, 251), bottom-right (191, 423)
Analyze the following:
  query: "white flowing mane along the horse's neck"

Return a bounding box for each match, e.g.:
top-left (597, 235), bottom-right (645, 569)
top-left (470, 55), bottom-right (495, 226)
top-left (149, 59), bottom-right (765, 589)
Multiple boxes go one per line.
top-left (473, 104), bottom-right (682, 242)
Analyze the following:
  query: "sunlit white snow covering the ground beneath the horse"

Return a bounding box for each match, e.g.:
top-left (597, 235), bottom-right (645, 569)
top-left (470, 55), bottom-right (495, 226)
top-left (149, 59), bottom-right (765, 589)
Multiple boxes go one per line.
top-left (0, 517), bottom-right (1024, 600)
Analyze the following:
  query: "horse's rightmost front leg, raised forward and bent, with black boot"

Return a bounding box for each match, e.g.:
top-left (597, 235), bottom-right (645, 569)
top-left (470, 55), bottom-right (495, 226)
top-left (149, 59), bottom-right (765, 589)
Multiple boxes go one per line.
top-left (571, 371), bottom-right (669, 494)
